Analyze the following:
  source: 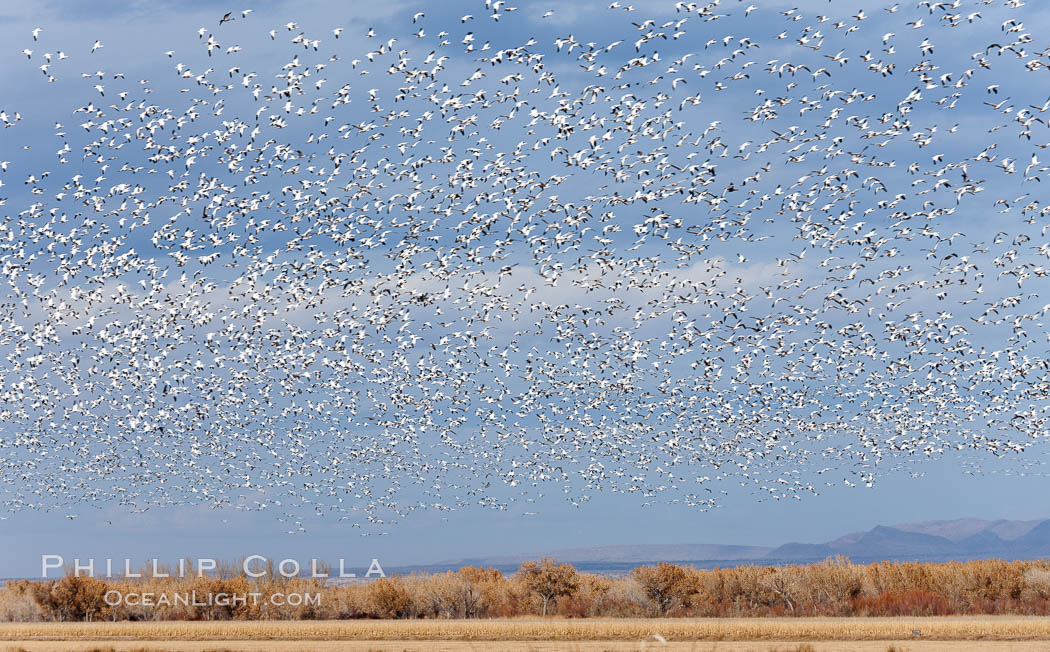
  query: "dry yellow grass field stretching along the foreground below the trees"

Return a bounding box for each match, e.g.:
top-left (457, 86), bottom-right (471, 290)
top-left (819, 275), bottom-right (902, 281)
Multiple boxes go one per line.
top-left (0, 616), bottom-right (1050, 652)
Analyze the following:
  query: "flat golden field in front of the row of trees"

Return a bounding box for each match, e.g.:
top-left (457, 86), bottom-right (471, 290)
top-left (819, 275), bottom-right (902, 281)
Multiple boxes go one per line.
top-left (0, 616), bottom-right (1050, 649)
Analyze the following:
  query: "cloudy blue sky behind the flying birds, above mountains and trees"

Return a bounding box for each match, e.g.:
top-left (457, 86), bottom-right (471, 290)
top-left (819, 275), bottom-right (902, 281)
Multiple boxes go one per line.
top-left (0, 0), bottom-right (1050, 574)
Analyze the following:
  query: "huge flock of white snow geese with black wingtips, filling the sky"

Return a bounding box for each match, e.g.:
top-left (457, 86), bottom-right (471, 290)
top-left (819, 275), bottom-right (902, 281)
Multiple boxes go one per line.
top-left (0, 0), bottom-right (1050, 531)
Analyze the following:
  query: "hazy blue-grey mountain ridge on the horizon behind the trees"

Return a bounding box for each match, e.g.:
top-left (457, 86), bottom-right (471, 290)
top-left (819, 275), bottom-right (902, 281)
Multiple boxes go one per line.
top-left (413, 519), bottom-right (1050, 570)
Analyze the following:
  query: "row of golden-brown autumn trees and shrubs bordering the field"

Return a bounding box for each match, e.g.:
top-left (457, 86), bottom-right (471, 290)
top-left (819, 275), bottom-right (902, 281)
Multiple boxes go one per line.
top-left (6, 556), bottom-right (1050, 621)
